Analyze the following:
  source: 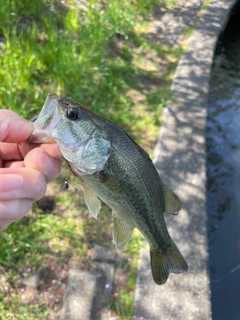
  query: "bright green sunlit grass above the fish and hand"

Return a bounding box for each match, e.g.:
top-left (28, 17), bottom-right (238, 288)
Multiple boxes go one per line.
top-left (0, 0), bottom-right (182, 141)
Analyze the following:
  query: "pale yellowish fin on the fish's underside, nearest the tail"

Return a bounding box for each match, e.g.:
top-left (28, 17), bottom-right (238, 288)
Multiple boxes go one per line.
top-left (112, 212), bottom-right (134, 250)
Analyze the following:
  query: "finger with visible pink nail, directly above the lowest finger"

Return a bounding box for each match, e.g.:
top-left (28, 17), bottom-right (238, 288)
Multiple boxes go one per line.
top-left (0, 167), bottom-right (46, 201)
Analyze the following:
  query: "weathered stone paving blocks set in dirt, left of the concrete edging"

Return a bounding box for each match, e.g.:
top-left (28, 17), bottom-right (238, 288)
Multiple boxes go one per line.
top-left (60, 245), bottom-right (119, 320)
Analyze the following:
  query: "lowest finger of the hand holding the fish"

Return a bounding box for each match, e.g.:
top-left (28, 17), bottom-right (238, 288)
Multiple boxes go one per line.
top-left (0, 199), bottom-right (32, 231)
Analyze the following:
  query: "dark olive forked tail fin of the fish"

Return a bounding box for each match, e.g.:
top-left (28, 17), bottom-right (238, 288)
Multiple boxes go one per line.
top-left (150, 242), bottom-right (188, 284)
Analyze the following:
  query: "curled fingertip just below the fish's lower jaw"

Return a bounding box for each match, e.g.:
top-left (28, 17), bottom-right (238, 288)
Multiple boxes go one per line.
top-left (24, 147), bottom-right (61, 182)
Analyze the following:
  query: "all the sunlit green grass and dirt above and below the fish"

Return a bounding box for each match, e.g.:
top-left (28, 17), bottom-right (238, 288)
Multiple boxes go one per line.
top-left (0, 0), bottom-right (183, 320)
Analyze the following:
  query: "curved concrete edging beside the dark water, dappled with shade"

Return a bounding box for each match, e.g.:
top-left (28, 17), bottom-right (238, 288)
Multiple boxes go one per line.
top-left (134, 0), bottom-right (236, 320)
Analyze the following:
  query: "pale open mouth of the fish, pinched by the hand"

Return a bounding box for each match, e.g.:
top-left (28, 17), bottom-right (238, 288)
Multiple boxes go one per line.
top-left (28, 93), bottom-right (60, 143)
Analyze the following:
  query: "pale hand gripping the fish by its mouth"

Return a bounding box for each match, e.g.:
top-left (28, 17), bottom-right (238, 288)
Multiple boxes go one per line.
top-left (0, 110), bottom-right (62, 231)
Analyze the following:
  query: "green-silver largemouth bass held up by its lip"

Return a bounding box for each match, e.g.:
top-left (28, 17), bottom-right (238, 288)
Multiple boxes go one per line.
top-left (29, 94), bottom-right (188, 285)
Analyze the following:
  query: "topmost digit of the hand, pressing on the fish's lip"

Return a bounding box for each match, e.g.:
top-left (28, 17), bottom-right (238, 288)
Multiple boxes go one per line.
top-left (0, 110), bottom-right (34, 143)
